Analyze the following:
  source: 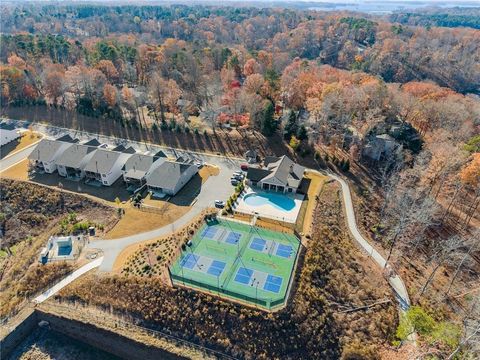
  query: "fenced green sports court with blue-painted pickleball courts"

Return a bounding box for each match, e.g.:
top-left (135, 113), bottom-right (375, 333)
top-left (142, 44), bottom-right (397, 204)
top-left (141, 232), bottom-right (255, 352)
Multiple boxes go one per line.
top-left (170, 219), bottom-right (300, 309)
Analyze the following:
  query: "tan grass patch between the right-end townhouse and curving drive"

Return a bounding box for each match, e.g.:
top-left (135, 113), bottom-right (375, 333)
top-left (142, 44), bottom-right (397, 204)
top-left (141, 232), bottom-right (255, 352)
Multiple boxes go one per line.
top-left (105, 202), bottom-right (191, 239)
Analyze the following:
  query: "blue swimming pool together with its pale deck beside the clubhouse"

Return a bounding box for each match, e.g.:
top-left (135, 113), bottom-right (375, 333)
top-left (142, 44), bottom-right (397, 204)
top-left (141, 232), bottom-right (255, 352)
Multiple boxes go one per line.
top-left (235, 188), bottom-right (304, 223)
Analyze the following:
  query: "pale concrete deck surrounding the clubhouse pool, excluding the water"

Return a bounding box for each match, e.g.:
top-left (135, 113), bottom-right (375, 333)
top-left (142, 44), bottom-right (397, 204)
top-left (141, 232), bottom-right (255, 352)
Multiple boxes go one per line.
top-left (235, 187), bottom-right (304, 224)
